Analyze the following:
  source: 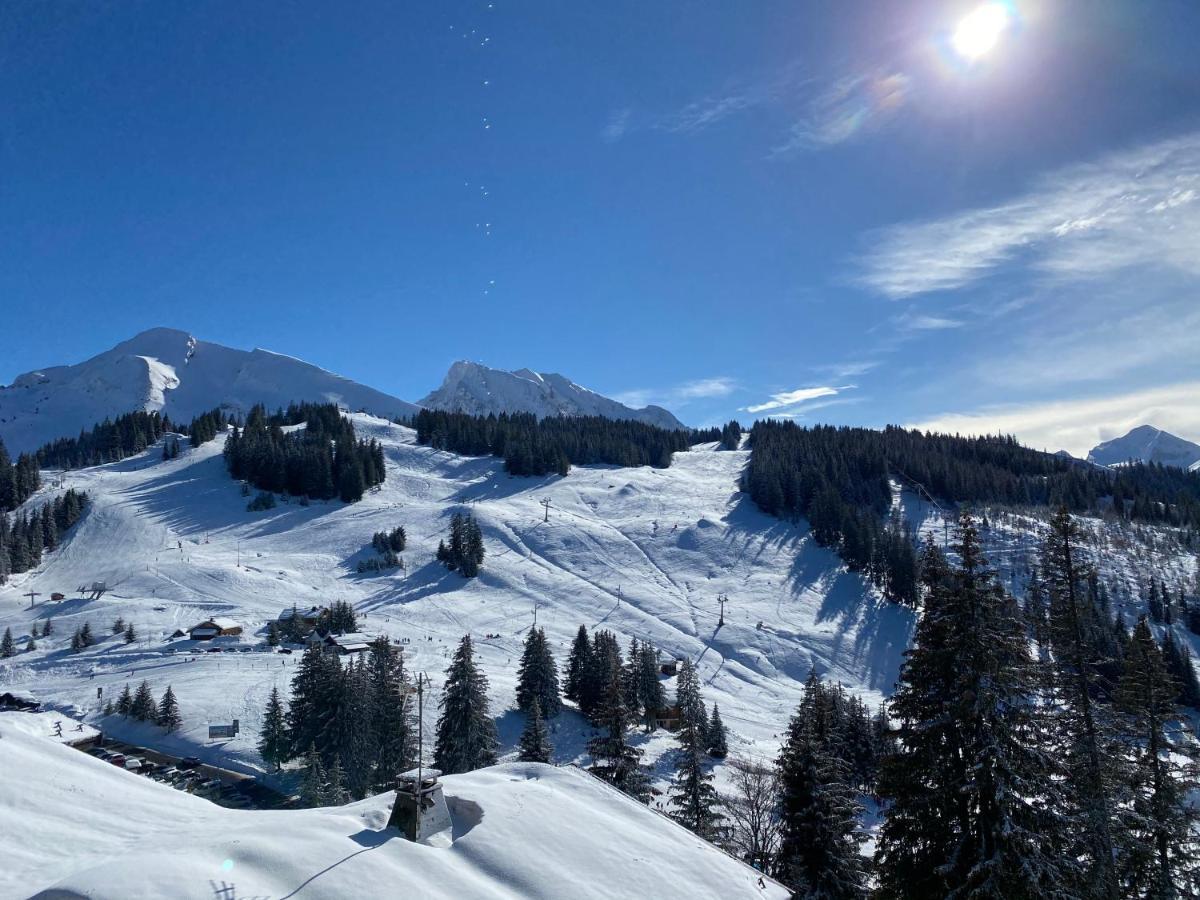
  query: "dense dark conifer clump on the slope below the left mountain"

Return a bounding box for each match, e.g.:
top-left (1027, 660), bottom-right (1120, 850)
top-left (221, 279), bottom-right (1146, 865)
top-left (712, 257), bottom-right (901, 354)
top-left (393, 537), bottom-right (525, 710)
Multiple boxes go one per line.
top-left (224, 403), bottom-right (386, 503)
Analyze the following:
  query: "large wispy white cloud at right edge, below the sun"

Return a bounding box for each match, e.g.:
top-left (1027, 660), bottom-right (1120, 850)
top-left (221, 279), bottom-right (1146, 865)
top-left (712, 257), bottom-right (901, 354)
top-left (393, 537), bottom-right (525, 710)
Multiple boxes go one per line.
top-left (856, 132), bottom-right (1200, 299)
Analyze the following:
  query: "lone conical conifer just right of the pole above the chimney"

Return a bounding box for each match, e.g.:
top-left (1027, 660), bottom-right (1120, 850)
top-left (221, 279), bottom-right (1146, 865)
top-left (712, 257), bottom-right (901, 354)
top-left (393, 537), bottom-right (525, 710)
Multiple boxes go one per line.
top-left (433, 635), bottom-right (497, 775)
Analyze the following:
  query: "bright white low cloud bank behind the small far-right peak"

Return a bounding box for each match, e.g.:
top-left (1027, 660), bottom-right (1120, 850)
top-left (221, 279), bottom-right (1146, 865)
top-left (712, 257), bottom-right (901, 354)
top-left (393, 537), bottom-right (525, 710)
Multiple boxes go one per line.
top-left (908, 382), bottom-right (1200, 457)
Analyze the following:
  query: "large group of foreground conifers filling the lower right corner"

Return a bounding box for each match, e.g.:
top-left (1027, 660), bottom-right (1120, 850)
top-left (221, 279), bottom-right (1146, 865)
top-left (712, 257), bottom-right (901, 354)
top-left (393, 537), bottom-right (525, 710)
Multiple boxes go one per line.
top-left (727, 509), bottom-right (1200, 900)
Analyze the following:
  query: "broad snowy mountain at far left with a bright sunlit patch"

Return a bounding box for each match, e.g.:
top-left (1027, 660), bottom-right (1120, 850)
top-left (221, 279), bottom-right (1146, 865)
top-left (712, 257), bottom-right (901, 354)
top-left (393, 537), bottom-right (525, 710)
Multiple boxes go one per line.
top-left (0, 328), bottom-right (416, 452)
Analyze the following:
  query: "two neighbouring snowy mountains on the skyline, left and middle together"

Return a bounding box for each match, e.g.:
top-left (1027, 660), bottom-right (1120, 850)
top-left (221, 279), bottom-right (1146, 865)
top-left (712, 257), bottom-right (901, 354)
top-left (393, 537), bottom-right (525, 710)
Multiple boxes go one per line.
top-left (0, 328), bottom-right (684, 454)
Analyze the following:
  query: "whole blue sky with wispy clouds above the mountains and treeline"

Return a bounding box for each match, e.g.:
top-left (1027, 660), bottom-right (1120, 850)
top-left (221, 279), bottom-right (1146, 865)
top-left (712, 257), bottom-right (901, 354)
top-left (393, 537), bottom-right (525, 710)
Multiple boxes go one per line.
top-left (0, 0), bottom-right (1200, 451)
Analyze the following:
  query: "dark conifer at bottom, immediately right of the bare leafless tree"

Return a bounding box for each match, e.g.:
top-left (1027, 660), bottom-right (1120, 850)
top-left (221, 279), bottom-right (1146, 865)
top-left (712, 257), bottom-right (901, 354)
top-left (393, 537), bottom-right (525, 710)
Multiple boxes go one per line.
top-left (775, 678), bottom-right (866, 900)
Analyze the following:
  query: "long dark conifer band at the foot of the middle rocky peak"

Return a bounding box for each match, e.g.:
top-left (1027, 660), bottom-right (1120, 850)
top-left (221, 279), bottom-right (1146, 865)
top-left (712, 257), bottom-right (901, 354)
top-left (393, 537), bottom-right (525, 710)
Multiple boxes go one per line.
top-left (412, 409), bottom-right (689, 475)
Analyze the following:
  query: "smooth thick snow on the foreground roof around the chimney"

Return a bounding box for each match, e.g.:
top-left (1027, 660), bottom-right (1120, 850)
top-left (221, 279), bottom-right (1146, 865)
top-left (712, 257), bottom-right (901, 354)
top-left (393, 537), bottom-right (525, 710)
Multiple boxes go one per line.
top-left (0, 713), bottom-right (787, 900)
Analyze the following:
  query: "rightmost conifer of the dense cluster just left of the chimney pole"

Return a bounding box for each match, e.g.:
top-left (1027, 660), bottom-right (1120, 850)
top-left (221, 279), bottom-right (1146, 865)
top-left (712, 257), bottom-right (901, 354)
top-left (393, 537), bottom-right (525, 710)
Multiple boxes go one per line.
top-left (367, 637), bottom-right (416, 791)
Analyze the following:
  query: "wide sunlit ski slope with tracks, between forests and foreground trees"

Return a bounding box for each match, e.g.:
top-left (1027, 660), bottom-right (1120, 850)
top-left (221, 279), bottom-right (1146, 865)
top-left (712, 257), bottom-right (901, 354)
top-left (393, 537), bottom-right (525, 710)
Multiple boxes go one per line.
top-left (0, 414), bottom-right (912, 776)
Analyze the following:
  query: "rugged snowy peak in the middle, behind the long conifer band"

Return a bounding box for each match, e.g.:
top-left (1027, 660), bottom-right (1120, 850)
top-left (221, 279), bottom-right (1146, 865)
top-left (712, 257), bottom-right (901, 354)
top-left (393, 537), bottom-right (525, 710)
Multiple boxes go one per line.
top-left (420, 360), bottom-right (685, 428)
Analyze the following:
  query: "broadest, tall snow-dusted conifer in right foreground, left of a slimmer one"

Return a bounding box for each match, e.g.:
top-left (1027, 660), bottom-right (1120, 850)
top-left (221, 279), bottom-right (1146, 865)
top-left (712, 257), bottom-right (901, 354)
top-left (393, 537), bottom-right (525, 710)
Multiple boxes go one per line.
top-left (876, 512), bottom-right (1078, 900)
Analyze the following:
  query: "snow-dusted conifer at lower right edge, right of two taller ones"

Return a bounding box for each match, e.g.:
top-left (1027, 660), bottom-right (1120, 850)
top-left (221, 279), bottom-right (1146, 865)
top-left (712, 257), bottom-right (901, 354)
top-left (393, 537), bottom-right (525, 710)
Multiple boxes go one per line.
top-left (1115, 617), bottom-right (1200, 900)
